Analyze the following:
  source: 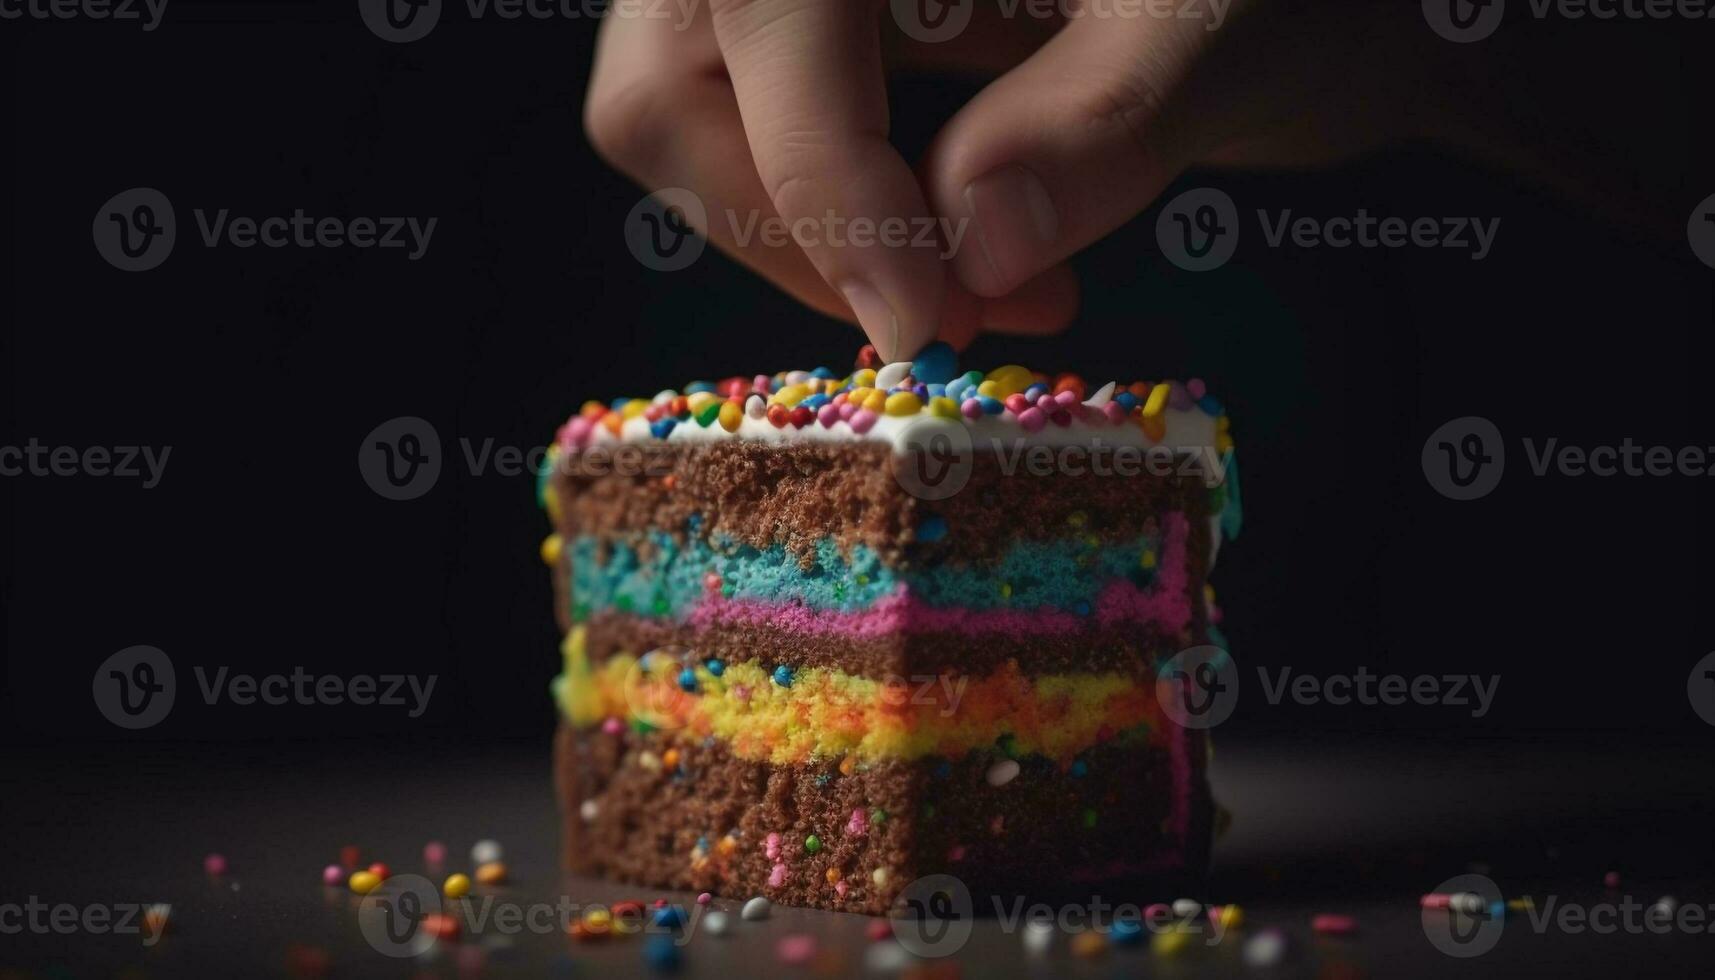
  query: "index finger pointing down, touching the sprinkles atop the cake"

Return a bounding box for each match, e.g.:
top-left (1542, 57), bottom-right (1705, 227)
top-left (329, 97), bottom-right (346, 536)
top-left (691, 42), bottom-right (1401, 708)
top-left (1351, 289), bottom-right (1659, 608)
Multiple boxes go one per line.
top-left (710, 0), bottom-right (947, 360)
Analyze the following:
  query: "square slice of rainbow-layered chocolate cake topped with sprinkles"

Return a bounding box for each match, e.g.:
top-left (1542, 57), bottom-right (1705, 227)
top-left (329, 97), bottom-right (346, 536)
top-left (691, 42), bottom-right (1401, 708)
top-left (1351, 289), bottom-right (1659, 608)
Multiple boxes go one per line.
top-left (540, 345), bottom-right (1238, 913)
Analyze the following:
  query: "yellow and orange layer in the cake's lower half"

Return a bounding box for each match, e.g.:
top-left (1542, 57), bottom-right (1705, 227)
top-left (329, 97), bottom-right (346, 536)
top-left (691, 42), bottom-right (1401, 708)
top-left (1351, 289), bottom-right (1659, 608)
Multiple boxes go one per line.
top-left (556, 626), bottom-right (1164, 765)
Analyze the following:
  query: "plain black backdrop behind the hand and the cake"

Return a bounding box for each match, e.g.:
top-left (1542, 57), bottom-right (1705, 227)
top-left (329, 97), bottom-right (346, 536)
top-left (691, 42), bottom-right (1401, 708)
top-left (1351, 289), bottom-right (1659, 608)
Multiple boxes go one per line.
top-left (0, 0), bottom-right (1715, 974)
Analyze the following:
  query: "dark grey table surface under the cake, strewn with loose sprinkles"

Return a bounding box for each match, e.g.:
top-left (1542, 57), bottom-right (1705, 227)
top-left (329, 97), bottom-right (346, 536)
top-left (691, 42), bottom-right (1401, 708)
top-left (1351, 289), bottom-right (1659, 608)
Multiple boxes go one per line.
top-left (0, 735), bottom-right (1715, 977)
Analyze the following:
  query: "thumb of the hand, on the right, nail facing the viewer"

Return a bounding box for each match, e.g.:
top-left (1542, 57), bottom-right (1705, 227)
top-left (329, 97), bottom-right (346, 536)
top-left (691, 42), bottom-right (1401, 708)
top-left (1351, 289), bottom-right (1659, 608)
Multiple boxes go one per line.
top-left (926, 15), bottom-right (1216, 297)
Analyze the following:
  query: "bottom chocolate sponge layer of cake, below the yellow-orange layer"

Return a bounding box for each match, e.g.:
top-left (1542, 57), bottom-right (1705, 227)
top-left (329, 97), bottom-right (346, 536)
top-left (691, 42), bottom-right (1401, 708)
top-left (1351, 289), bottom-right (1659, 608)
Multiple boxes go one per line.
top-left (554, 726), bottom-right (1211, 915)
